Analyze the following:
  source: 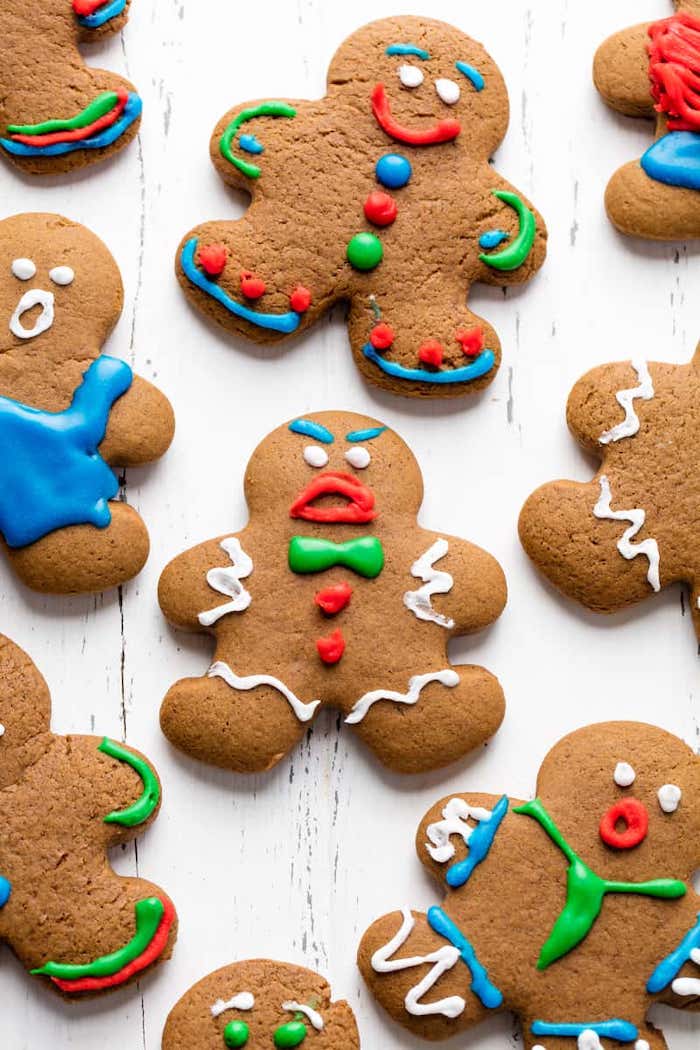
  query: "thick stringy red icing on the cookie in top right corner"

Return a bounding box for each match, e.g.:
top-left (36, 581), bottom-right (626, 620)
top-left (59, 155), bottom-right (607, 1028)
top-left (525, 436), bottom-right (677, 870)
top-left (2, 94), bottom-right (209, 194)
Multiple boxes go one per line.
top-left (649, 12), bottom-right (700, 131)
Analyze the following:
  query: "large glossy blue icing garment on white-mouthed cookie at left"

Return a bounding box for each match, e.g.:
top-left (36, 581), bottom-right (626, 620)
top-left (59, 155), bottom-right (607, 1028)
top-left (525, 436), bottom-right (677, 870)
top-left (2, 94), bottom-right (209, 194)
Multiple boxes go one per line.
top-left (0, 355), bottom-right (133, 547)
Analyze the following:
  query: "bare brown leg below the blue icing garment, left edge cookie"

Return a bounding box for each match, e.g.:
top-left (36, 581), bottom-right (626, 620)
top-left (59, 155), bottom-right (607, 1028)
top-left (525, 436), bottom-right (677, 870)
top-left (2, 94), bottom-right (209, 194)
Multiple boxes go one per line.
top-left (5, 503), bottom-right (149, 594)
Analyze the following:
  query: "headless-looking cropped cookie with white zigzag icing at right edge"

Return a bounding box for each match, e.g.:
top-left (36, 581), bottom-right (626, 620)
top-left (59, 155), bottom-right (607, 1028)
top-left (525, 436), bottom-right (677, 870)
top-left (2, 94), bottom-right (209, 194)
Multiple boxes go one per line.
top-left (518, 351), bottom-right (700, 638)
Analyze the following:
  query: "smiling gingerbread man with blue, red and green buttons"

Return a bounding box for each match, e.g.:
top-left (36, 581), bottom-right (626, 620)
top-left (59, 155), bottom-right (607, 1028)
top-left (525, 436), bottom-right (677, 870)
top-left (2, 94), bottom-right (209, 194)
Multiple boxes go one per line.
top-left (176, 17), bottom-right (546, 397)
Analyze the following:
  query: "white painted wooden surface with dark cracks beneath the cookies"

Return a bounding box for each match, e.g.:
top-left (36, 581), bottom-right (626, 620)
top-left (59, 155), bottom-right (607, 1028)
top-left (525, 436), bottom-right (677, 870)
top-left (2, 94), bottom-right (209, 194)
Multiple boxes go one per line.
top-left (0, 0), bottom-right (700, 1050)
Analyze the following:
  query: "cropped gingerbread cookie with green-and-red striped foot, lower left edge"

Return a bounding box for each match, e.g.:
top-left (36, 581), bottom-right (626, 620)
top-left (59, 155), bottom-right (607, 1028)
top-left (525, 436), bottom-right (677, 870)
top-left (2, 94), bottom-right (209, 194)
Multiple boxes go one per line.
top-left (0, 636), bottom-right (177, 996)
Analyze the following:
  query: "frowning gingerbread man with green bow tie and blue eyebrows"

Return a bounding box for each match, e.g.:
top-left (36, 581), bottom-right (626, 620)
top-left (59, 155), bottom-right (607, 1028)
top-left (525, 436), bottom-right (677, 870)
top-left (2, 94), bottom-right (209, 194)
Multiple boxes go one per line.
top-left (158, 412), bottom-right (506, 773)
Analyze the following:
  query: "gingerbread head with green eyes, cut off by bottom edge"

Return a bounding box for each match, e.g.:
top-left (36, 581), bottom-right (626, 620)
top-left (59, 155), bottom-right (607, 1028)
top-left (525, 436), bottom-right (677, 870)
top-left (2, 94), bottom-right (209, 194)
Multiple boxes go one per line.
top-left (163, 959), bottom-right (360, 1050)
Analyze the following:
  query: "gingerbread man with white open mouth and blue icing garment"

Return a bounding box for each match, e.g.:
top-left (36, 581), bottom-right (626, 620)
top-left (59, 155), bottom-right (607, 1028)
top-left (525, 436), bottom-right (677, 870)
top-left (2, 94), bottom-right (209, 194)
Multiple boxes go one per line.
top-left (0, 213), bottom-right (174, 593)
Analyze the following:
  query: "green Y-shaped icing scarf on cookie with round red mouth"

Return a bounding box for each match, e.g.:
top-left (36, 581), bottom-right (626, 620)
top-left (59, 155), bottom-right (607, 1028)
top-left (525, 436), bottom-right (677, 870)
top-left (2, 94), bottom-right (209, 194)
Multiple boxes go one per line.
top-left (513, 798), bottom-right (687, 970)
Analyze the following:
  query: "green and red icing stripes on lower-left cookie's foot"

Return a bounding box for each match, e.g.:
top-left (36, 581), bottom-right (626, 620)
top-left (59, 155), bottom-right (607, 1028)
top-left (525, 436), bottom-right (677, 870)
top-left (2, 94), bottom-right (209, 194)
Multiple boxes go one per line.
top-left (30, 897), bottom-right (175, 994)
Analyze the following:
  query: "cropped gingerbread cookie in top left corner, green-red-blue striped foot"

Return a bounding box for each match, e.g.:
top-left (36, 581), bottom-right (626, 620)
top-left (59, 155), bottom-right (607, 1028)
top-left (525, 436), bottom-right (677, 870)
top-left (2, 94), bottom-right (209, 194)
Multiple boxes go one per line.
top-left (0, 0), bottom-right (142, 175)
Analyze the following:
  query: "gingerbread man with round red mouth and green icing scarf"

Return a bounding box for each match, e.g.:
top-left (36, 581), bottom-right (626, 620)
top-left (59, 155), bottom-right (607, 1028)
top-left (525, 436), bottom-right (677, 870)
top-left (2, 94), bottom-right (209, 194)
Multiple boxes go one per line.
top-left (358, 722), bottom-right (700, 1050)
